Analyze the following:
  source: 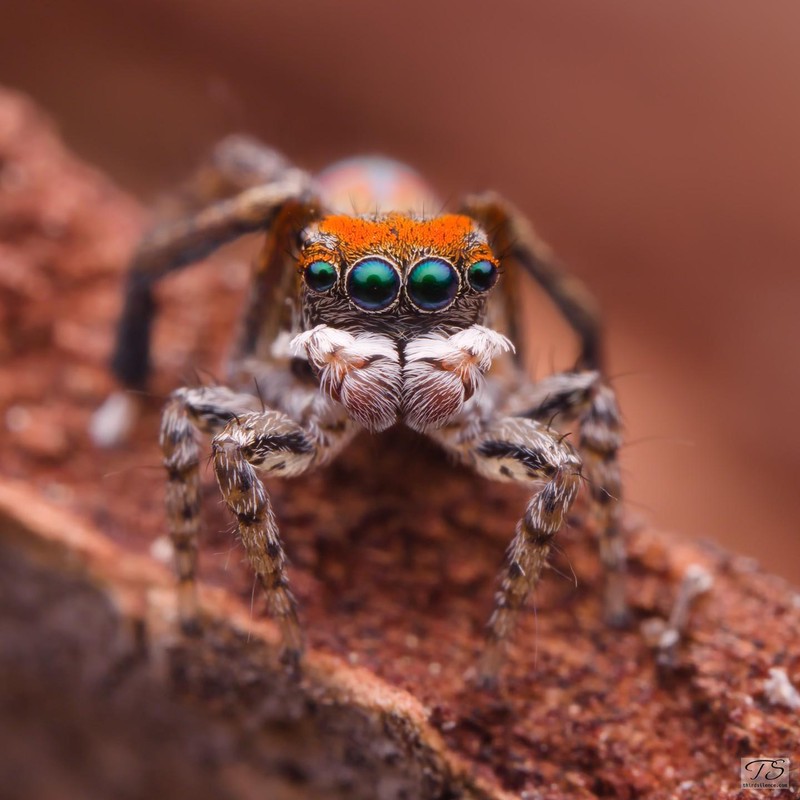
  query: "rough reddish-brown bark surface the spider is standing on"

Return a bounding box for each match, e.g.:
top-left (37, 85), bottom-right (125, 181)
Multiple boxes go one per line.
top-left (0, 93), bottom-right (800, 798)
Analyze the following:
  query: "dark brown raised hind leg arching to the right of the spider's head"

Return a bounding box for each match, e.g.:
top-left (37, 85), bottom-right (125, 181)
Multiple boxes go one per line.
top-left (462, 192), bottom-right (603, 369)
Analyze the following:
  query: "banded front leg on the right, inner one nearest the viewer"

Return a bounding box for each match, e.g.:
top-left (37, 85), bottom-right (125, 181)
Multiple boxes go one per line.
top-left (429, 413), bottom-right (581, 684)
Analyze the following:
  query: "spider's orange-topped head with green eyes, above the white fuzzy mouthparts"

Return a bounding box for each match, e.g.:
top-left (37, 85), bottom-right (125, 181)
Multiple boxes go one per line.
top-left (298, 213), bottom-right (498, 334)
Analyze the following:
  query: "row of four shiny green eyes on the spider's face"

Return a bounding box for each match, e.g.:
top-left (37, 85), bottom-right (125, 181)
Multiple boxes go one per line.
top-left (303, 256), bottom-right (497, 312)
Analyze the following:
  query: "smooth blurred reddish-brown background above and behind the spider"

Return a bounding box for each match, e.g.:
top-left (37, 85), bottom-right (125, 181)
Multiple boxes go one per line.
top-left (0, 0), bottom-right (800, 581)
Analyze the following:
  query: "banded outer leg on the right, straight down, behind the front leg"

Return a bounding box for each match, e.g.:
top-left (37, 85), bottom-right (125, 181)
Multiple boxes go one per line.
top-left (512, 371), bottom-right (629, 626)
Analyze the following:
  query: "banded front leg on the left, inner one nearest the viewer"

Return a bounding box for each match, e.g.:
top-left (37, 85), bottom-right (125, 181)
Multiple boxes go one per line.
top-left (212, 409), bottom-right (357, 665)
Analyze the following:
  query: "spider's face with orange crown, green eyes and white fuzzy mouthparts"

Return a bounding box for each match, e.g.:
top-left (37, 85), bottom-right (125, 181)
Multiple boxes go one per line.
top-left (293, 213), bottom-right (511, 431)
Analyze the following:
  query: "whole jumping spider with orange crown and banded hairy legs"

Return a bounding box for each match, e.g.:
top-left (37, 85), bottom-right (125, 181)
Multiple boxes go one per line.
top-left (104, 137), bottom-right (626, 680)
